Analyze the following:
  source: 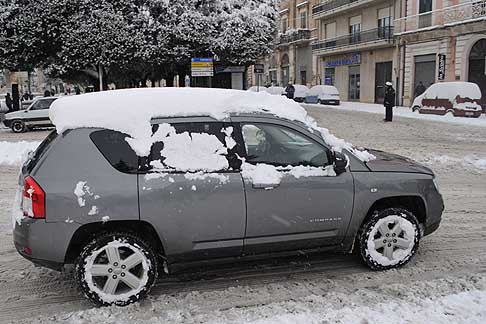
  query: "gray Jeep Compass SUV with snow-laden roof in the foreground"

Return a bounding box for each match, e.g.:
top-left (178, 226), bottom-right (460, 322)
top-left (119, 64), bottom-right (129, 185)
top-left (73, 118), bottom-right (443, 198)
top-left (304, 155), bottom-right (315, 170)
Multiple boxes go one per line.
top-left (14, 113), bottom-right (444, 305)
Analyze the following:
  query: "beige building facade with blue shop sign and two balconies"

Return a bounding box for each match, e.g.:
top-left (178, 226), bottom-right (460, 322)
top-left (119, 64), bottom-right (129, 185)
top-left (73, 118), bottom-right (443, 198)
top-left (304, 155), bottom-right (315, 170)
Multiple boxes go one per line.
top-left (312, 0), bottom-right (400, 103)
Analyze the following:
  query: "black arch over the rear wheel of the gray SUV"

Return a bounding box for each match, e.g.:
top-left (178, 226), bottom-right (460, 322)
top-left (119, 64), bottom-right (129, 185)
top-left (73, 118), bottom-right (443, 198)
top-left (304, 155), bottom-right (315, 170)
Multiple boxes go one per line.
top-left (64, 220), bottom-right (165, 264)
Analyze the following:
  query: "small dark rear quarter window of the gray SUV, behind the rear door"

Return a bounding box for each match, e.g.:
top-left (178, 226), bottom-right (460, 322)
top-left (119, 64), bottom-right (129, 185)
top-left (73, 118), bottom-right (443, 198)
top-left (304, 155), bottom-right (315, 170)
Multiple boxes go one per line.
top-left (90, 129), bottom-right (138, 173)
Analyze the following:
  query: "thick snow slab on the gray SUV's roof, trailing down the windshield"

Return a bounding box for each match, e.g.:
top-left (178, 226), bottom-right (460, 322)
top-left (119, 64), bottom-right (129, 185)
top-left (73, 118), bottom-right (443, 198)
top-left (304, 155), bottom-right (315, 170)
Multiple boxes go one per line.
top-left (49, 88), bottom-right (373, 161)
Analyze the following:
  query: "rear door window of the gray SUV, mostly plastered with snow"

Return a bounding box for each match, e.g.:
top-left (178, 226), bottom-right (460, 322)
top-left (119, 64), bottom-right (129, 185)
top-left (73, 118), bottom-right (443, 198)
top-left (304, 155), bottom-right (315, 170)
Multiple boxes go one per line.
top-left (142, 122), bottom-right (241, 171)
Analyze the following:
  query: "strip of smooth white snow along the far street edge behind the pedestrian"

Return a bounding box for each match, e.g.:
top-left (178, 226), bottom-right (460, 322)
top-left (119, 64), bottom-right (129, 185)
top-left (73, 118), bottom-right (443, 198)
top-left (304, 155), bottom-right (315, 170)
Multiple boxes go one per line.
top-left (303, 101), bottom-right (486, 127)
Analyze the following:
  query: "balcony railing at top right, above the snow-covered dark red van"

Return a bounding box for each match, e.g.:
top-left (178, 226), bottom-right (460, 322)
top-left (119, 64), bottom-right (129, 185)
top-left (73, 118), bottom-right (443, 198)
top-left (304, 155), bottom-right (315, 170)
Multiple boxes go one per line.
top-left (395, 0), bottom-right (486, 34)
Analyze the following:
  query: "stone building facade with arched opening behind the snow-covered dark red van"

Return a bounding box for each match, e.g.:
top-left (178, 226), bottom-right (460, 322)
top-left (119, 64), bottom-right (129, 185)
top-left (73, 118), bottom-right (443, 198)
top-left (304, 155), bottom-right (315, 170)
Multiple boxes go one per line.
top-left (395, 0), bottom-right (486, 106)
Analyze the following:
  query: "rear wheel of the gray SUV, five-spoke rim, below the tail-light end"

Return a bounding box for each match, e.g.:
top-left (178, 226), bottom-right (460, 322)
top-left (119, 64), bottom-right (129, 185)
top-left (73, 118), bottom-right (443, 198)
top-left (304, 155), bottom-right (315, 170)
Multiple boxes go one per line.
top-left (75, 232), bottom-right (158, 306)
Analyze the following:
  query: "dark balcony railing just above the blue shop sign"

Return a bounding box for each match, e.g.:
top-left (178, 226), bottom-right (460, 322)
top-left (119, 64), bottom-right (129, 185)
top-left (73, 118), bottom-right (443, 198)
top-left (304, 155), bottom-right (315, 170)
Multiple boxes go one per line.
top-left (312, 26), bottom-right (393, 51)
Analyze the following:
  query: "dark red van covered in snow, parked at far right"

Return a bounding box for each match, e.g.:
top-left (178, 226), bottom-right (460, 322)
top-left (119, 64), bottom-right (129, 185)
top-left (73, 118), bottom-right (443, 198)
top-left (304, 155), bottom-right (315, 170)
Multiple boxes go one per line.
top-left (412, 81), bottom-right (482, 117)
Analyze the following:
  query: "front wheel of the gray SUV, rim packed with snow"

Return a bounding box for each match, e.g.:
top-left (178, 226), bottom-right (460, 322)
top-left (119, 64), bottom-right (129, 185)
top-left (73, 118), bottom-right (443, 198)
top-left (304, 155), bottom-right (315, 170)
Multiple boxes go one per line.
top-left (358, 208), bottom-right (420, 270)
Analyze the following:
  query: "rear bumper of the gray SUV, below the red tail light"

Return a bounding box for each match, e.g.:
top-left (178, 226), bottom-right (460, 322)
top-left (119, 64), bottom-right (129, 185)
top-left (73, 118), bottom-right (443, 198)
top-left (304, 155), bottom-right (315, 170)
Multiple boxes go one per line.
top-left (13, 218), bottom-right (78, 270)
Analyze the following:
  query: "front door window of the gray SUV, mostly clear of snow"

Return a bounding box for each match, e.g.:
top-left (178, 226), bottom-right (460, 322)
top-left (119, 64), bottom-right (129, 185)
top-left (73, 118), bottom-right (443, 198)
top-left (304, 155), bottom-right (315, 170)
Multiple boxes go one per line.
top-left (241, 123), bottom-right (330, 167)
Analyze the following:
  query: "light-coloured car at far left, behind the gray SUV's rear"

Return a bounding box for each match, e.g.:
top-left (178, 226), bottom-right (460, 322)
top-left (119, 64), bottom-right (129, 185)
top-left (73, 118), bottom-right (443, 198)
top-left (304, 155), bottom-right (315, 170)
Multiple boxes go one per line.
top-left (3, 97), bottom-right (57, 133)
